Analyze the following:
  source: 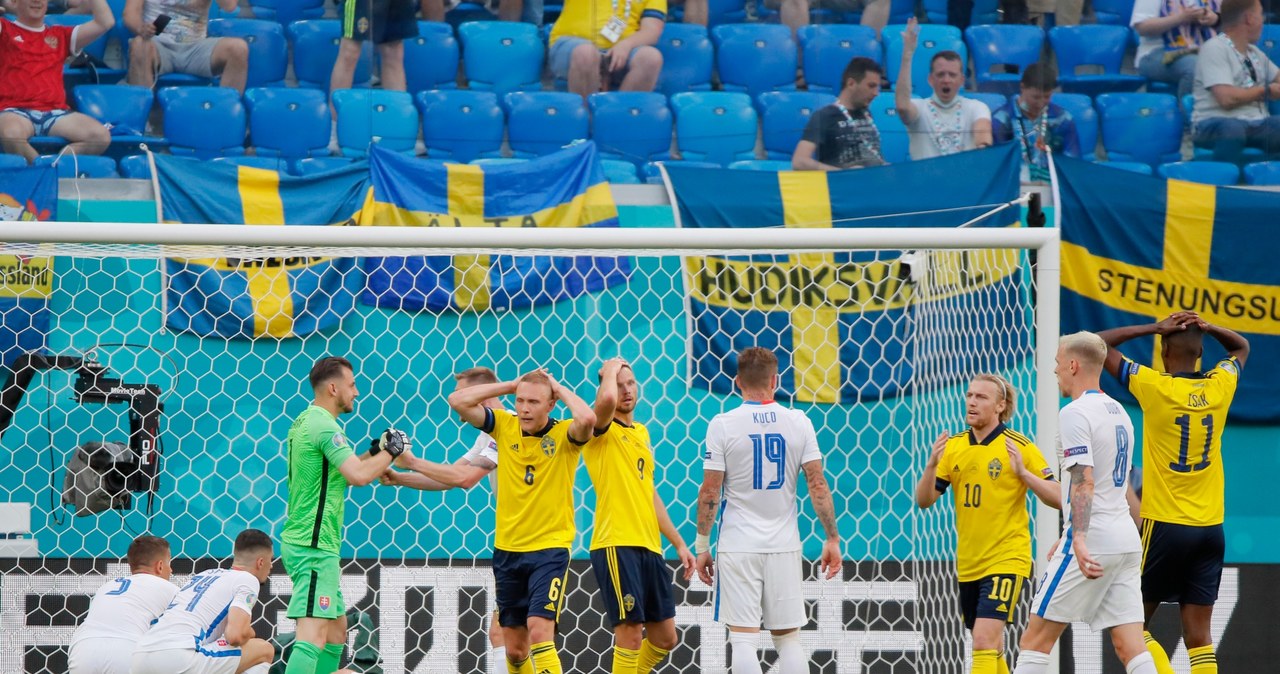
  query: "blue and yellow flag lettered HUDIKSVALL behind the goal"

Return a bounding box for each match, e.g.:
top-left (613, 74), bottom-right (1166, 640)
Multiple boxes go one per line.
top-left (667, 145), bottom-right (1028, 403)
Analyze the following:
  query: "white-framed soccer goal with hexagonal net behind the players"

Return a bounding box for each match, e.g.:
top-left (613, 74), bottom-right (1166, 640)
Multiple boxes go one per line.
top-left (0, 222), bottom-right (1059, 674)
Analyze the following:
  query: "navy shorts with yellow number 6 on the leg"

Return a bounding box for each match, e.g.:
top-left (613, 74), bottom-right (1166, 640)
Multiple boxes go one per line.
top-left (493, 547), bottom-right (568, 627)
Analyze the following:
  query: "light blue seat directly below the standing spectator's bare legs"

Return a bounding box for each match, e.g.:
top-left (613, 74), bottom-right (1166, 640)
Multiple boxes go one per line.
top-left (333, 90), bottom-right (419, 157)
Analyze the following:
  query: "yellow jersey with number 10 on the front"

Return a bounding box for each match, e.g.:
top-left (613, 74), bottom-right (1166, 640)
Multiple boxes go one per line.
top-left (937, 423), bottom-right (1053, 582)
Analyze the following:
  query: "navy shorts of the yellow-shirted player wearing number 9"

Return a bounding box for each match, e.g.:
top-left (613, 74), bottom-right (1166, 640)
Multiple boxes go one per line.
top-left (591, 546), bottom-right (676, 627)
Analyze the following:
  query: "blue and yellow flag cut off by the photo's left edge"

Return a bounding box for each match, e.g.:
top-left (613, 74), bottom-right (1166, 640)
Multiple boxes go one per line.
top-left (0, 166), bottom-right (58, 366)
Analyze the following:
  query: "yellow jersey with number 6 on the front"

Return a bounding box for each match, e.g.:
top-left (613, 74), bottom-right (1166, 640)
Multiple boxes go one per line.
top-left (481, 409), bottom-right (582, 553)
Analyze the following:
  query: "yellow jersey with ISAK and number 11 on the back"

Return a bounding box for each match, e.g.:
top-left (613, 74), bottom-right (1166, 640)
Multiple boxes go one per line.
top-left (1120, 358), bottom-right (1240, 527)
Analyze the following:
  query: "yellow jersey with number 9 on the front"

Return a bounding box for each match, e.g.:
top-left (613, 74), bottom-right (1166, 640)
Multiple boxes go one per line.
top-left (582, 419), bottom-right (662, 554)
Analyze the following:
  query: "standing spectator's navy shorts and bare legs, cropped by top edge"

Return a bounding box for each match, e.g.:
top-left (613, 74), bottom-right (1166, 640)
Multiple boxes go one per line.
top-left (329, 0), bottom-right (417, 93)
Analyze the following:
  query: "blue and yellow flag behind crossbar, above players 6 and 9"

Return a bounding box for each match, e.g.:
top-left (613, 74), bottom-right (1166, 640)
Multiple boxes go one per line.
top-left (361, 143), bottom-right (631, 312)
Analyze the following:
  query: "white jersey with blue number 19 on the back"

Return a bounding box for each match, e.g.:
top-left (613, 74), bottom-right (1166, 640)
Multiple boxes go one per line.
top-left (703, 400), bottom-right (822, 553)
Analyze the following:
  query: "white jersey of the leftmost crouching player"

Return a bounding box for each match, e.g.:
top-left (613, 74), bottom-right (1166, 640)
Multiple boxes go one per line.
top-left (70, 573), bottom-right (178, 650)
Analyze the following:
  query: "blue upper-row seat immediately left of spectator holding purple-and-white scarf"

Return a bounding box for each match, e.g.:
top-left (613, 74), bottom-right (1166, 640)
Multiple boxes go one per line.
top-left (1048, 26), bottom-right (1147, 96)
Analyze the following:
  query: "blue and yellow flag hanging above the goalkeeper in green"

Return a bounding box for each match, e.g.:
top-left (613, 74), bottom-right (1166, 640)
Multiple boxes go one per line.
top-left (155, 156), bottom-right (369, 339)
